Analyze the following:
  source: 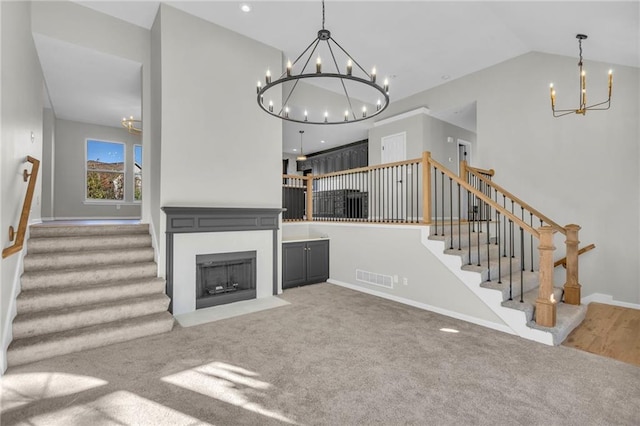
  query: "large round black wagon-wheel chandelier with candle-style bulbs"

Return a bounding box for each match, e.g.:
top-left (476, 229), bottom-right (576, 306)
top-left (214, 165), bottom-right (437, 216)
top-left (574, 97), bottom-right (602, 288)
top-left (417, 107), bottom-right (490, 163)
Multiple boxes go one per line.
top-left (257, 0), bottom-right (389, 124)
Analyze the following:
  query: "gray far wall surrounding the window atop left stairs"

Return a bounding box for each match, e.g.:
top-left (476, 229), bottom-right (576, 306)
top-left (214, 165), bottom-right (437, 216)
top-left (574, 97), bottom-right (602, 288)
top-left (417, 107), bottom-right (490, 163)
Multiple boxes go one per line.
top-left (52, 119), bottom-right (144, 219)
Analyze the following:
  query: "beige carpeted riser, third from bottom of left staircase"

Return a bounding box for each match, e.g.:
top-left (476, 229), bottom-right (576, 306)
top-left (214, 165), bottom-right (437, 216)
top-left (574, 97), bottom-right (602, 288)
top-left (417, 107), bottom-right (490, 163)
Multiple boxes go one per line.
top-left (16, 280), bottom-right (165, 313)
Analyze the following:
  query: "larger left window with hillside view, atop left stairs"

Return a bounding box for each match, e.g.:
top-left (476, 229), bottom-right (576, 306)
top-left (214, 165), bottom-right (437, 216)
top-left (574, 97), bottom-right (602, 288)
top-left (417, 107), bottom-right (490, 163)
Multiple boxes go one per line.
top-left (86, 139), bottom-right (124, 200)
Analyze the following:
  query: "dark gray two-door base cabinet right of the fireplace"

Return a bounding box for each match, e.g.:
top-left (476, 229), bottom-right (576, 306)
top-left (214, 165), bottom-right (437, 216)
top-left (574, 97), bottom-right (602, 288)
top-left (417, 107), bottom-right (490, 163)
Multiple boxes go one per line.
top-left (282, 240), bottom-right (329, 289)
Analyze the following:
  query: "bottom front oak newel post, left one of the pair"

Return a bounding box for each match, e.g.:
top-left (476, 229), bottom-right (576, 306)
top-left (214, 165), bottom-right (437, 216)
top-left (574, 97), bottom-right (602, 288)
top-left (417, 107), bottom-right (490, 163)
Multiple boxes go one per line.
top-left (536, 226), bottom-right (557, 327)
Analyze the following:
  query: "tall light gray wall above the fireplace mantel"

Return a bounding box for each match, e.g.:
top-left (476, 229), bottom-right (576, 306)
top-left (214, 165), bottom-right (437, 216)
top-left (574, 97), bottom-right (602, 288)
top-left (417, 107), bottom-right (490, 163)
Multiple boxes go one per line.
top-left (161, 4), bottom-right (282, 207)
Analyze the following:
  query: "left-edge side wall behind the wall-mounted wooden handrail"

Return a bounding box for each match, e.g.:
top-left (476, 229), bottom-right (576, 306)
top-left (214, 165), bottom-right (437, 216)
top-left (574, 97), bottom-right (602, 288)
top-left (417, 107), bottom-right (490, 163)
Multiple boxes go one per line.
top-left (0, 2), bottom-right (43, 371)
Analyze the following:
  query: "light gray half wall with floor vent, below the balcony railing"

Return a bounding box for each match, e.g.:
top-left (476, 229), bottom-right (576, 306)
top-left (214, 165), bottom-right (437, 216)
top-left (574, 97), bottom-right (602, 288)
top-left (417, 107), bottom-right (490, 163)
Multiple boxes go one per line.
top-left (283, 222), bottom-right (506, 329)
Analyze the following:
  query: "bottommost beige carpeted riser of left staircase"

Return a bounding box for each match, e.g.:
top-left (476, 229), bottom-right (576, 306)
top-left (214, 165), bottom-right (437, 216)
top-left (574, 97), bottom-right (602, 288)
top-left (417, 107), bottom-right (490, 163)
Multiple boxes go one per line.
top-left (7, 313), bottom-right (173, 367)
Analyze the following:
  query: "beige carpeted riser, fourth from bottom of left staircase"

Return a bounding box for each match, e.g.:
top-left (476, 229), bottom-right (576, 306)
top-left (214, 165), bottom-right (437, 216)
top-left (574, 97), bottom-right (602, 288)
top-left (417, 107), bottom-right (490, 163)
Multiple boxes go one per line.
top-left (21, 263), bottom-right (157, 290)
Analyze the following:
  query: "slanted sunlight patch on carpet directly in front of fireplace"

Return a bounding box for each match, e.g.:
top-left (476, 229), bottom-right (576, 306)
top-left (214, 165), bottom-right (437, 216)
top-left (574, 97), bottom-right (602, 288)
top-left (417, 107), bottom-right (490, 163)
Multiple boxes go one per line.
top-left (162, 362), bottom-right (296, 424)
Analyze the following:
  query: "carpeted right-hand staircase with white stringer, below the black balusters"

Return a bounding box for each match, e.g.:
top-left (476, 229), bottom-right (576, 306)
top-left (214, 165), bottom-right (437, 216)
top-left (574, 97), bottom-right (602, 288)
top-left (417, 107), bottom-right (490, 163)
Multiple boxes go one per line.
top-left (425, 222), bottom-right (587, 345)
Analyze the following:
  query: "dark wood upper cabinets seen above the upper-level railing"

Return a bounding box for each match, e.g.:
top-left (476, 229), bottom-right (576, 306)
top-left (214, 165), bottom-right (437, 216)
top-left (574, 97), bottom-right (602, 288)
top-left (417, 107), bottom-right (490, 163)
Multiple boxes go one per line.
top-left (297, 140), bottom-right (369, 175)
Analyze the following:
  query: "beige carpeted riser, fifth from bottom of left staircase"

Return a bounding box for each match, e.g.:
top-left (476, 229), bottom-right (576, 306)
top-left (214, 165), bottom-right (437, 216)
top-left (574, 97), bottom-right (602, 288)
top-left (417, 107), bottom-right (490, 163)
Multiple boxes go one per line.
top-left (24, 247), bottom-right (154, 272)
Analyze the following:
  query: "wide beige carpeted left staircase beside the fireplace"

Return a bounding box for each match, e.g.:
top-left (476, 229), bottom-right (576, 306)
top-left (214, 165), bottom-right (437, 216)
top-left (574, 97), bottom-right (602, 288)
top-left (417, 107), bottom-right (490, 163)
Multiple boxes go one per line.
top-left (7, 224), bottom-right (173, 366)
